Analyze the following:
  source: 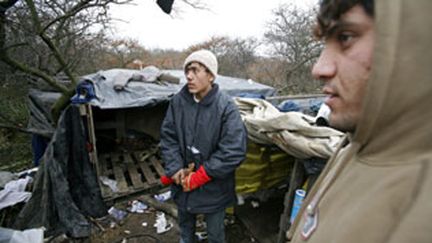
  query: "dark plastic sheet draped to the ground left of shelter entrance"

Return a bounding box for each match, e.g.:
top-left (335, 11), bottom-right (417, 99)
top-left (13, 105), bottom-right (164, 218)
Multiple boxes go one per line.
top-left (14, 106), bottom-right (107, 237)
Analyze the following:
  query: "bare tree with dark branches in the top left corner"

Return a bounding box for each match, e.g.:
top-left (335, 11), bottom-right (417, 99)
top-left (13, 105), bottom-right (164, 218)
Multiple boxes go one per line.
top-left (0, 0), bottom-right (134, 121)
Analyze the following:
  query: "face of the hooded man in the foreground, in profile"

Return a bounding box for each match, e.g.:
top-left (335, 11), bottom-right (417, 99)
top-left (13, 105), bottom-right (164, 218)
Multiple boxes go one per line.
top-left (312, 5), bottom-right (374, 132)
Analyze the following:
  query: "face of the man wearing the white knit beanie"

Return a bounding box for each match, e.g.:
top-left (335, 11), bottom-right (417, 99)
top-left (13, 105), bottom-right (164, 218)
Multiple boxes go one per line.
top-left (185, 62), bottom-right (214, 100)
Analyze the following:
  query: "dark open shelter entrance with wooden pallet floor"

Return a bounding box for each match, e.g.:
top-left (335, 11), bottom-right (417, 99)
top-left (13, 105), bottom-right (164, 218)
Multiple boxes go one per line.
top-left (83, 103), bottom-right (168, 201)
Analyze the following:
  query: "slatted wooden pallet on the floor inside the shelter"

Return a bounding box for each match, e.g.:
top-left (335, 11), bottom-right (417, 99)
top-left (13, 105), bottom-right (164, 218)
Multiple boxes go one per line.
top-left (98, 151), bottom-right (164, 200)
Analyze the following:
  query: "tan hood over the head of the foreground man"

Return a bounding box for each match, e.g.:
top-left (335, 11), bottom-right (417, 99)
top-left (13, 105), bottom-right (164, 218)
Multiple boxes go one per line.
top-left (353, 0), bottom-right (432, 164)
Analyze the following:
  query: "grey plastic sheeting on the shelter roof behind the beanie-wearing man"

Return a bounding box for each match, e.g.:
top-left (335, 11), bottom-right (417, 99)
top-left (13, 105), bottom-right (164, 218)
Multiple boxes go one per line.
top-left (83, 69), bottom-right (275, 109)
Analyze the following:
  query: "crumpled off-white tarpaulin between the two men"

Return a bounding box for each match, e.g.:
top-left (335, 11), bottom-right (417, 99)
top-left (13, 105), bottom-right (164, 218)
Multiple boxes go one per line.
top-left (235, 98), bottom-right (343, 159)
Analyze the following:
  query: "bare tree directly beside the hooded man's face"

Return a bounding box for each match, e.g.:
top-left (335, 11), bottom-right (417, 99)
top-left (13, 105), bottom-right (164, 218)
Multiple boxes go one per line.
top-left (264, 4), bottom-right (321, 93)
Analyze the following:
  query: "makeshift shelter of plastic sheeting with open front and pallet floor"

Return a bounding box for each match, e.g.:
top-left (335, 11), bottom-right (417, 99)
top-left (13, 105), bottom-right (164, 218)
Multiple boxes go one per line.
top-left (15, 67), bottom-right (275, 237)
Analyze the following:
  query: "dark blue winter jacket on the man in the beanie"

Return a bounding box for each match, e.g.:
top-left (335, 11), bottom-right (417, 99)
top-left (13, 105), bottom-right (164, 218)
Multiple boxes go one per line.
top-left (161, 84), bottom-right (247, 213)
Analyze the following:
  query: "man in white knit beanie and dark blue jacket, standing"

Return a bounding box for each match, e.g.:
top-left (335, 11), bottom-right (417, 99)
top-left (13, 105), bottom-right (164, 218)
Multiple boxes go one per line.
top-left (161, 50), bottom-right (247, 243)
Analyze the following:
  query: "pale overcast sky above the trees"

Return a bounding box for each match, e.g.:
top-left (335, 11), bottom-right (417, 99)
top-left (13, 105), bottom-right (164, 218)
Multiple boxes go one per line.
top-left (111, 0), bottom-right (318, 50)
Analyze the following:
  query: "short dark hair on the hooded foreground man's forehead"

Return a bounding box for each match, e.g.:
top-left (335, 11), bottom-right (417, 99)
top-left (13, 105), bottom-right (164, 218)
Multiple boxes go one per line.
top-left (314, 0), bottom-right (374, 38)
